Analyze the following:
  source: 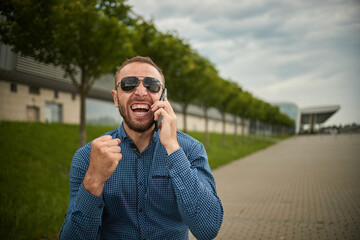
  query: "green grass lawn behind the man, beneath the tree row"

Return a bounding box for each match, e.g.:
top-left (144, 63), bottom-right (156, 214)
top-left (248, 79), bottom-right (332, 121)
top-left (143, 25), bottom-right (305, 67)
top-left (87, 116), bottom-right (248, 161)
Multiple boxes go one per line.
top-left (0, 122), bottom-right (286, 239)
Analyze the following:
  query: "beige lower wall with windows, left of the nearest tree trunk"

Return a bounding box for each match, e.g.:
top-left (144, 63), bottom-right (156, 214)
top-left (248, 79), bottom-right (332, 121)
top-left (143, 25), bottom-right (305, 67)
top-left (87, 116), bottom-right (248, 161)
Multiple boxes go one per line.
top-left (0, 81), bottom-right (80, 124)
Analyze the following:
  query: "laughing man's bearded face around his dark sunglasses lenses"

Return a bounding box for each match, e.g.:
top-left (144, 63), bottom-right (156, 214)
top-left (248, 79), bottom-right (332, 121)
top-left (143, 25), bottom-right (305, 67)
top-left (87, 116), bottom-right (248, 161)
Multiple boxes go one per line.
top-left (112, 62), bottom-right (164, 132)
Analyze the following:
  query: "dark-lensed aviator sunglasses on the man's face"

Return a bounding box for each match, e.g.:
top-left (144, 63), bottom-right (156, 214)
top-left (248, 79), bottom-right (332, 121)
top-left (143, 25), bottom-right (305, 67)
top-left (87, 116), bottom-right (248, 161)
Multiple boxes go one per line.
top-left (117, 76), bottom-right (163, 93)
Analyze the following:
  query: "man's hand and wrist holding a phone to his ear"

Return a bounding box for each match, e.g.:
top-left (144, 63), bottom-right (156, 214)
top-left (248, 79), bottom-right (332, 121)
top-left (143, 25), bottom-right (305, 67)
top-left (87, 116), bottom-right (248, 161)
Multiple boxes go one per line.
top-left (151, 97), bottom-right (180, 154)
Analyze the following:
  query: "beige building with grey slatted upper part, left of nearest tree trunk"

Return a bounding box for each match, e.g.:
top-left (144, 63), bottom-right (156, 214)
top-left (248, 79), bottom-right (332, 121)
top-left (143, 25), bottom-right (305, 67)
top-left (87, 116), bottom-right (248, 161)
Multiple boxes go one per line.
top-left (0, 44), bottom-right (79, 123)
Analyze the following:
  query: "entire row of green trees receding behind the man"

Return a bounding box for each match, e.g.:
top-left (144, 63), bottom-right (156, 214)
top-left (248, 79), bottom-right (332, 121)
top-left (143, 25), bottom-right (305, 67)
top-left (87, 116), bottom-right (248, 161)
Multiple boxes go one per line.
top-left (0, 0), bottom-right (293, 146)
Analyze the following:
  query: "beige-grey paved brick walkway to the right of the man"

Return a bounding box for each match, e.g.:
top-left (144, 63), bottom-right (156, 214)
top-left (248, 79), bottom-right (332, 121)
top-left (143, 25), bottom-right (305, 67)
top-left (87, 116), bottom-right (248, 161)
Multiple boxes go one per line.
top-left (191, 135), bottom-right (360, 240)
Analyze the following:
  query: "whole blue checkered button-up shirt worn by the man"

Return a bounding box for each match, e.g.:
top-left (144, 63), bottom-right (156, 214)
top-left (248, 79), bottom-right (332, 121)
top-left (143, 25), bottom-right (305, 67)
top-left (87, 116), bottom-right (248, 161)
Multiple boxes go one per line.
top-left (60, 125), bottom-right (223, 240)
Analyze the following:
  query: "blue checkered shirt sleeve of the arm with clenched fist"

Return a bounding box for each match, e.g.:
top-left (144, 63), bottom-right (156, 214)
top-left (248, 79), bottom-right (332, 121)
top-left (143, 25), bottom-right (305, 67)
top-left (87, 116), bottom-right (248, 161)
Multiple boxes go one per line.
top-left (59, 151), bottom-right (104, 240)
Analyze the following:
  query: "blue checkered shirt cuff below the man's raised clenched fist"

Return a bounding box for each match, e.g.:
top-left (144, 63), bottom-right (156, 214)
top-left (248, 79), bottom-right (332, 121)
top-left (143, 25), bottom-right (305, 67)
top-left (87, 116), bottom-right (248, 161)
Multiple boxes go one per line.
top-left (76, 184), bottom-right (105, 218)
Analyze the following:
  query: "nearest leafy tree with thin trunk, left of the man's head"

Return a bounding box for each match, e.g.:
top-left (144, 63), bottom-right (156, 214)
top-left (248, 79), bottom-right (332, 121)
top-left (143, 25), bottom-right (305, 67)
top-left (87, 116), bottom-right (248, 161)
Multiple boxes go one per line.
top-left (0, 0), bottom-right (133, 146)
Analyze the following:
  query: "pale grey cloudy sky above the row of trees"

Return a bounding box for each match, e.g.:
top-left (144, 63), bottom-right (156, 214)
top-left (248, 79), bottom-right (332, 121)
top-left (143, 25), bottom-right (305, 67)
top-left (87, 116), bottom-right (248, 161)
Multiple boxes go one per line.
top-left (128, 0), bottom-right (360, 125)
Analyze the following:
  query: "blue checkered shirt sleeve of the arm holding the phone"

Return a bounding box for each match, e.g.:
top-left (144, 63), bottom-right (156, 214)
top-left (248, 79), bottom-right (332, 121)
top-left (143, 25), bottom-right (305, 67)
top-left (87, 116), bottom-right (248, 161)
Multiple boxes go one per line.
top-left (167, 142), bottom-right (223, 239)
